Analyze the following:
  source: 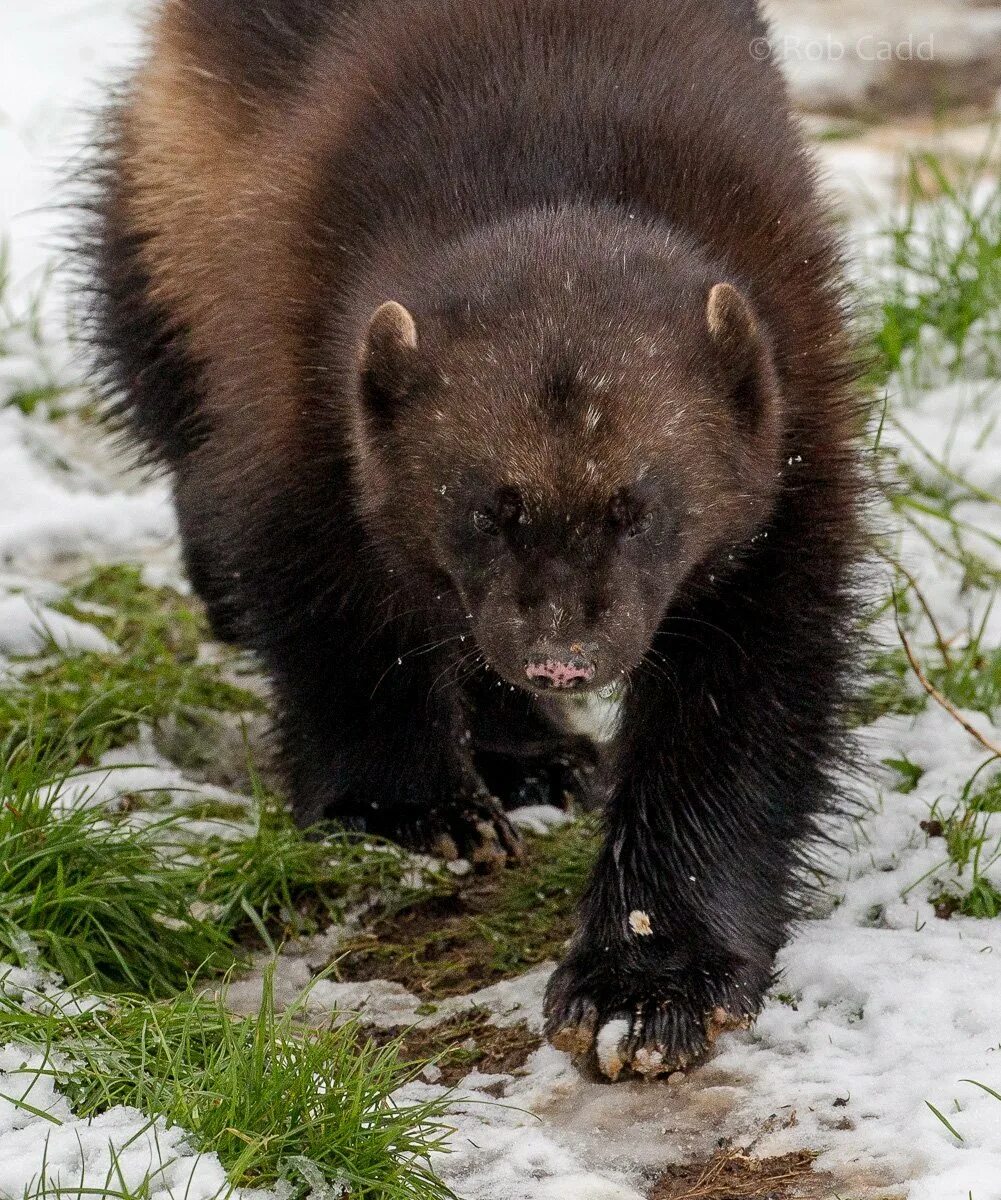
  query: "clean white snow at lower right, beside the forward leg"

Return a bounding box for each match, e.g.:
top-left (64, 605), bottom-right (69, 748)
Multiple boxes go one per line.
top-left (713, 708), bottom-right (1001, 1200)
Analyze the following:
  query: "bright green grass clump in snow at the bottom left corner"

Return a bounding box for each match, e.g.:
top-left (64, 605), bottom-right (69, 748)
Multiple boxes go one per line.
top-left (0, 980), bottom-right (451, 1200)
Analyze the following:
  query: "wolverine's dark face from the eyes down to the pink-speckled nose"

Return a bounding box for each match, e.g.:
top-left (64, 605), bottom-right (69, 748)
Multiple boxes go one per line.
top-left (439, 466), bottom-right (689, 691)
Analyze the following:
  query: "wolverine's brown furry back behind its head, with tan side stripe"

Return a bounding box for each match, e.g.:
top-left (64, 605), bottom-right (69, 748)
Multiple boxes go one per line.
top-left (90, 0), bottom-right (833, 470)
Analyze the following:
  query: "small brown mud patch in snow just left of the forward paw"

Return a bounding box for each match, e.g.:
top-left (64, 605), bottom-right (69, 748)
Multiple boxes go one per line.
top-left (374, 1010), bottom-right (543, 1087)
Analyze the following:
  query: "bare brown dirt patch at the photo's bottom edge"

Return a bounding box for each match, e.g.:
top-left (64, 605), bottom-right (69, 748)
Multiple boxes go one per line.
top-left (651, 1146), bottom-right (834, 1200)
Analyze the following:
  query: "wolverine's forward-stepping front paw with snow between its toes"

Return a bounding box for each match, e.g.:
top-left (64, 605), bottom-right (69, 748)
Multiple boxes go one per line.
top-left (545, 952), bottom-right (762, 1080)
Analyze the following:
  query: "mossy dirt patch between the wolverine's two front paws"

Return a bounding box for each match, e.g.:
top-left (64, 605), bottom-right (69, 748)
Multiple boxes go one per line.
top-left (334, 821), bottom-right (598, 1001)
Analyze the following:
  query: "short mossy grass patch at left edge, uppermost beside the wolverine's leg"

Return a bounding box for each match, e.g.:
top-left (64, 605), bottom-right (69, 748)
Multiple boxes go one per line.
top-left (0, 565), bottom-right (263, 769)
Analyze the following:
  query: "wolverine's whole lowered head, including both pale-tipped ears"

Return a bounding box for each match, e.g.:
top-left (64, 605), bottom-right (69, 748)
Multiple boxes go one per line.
top-left (348, 215), bottom-right (781, 691)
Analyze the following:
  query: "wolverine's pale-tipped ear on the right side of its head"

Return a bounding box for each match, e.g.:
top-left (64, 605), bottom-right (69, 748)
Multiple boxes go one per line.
top-left (706, 283), bottom-right (778, 426)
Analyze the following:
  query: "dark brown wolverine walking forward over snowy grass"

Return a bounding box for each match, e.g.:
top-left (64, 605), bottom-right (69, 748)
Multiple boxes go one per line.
top-left (84, 0), bottom-right (864, 1075)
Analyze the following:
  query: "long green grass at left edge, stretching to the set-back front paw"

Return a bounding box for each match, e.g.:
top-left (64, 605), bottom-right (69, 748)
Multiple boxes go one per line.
top-left (0, 715), bottom-right (432, 995)
